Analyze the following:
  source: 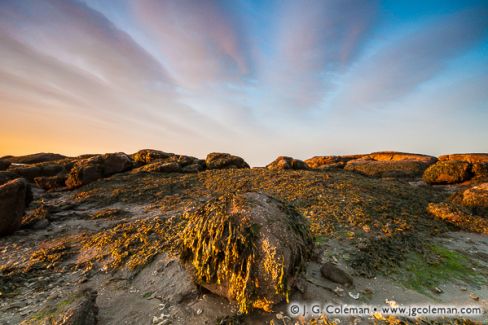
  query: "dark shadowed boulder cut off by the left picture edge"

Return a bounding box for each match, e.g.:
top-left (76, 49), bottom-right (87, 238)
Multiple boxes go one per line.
top-left (0, 178), bottom-right (28, 236)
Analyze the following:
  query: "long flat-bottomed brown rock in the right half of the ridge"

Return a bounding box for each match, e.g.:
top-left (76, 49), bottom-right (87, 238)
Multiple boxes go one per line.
top-left (344, 159), bottom-right (427, 178)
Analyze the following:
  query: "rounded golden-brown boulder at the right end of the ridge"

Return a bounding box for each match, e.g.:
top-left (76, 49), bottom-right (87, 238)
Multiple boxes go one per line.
top-left (422, 160), bottom-right (471, 184)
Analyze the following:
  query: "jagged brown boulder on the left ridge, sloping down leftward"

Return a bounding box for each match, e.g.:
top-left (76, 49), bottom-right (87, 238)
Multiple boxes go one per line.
top-left (66, 152), bottom-right (133, 188)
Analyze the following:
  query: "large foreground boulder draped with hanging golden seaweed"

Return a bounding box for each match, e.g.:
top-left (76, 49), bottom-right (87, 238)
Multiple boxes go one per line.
top-left (180, 192), bottom-right (312, 313)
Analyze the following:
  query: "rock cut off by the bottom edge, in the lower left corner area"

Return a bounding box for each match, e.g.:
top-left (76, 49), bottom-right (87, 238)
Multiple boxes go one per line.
top-left (21, 289), bottom-right (98, 325)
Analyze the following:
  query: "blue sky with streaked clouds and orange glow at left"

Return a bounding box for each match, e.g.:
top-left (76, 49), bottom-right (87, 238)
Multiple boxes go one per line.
top-left (0, 0), bottom-right (488, 166)
